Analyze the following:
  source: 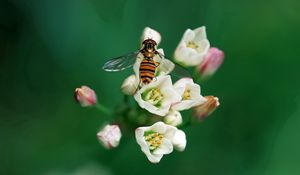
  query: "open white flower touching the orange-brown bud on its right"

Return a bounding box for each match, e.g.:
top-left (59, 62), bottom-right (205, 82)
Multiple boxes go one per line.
top-left (172, 78), bottom-right (206, 111)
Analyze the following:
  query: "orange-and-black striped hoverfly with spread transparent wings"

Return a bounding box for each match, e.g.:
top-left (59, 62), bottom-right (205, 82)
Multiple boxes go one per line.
top-left (102, 39), bottom-right (190, 85)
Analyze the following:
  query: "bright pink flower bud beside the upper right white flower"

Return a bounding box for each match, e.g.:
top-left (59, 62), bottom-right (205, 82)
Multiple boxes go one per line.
top-left (198, 47), bottom-right (224, 78)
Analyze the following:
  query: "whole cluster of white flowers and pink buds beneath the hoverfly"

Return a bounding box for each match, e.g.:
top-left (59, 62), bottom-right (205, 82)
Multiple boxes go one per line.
top-left (75, 27), bottom-right (224, 163)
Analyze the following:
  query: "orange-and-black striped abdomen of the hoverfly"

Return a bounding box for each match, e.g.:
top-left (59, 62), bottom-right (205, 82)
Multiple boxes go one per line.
top-left (140, 59), bottom-right (156, 84)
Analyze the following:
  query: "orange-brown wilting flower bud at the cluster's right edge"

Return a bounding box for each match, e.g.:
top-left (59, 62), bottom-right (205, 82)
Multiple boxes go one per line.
top-left (194, 96), bottom-right (220, 121)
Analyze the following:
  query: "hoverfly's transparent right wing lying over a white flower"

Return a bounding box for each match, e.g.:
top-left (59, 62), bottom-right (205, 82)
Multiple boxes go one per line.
top-left (158, 53), bottom-right (191, 78)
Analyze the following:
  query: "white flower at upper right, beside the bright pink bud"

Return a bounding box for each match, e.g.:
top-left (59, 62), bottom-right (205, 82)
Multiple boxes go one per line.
top-left (175, 26), bottom-right (210, 66)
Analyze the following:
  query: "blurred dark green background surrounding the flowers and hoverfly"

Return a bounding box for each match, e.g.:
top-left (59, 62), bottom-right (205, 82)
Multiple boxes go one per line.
top-left (0, 0), bottom-right (300, 175)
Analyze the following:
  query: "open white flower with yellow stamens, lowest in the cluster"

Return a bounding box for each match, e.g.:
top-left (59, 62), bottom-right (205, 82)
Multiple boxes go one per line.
top-left (135, 122), bottom-right (177, 163)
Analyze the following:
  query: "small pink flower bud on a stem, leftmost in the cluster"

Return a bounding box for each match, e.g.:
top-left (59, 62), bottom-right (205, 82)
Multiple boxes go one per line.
top-left (75, 86), bottom-right (97, 107)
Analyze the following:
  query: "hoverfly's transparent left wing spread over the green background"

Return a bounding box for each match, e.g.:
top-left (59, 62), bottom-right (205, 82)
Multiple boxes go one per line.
top-left (102, 51), bottom-right (139, 72)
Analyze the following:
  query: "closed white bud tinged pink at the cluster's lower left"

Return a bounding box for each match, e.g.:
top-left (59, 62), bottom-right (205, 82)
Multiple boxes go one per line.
top-left (97, 125), bottom-right (122, 149)
